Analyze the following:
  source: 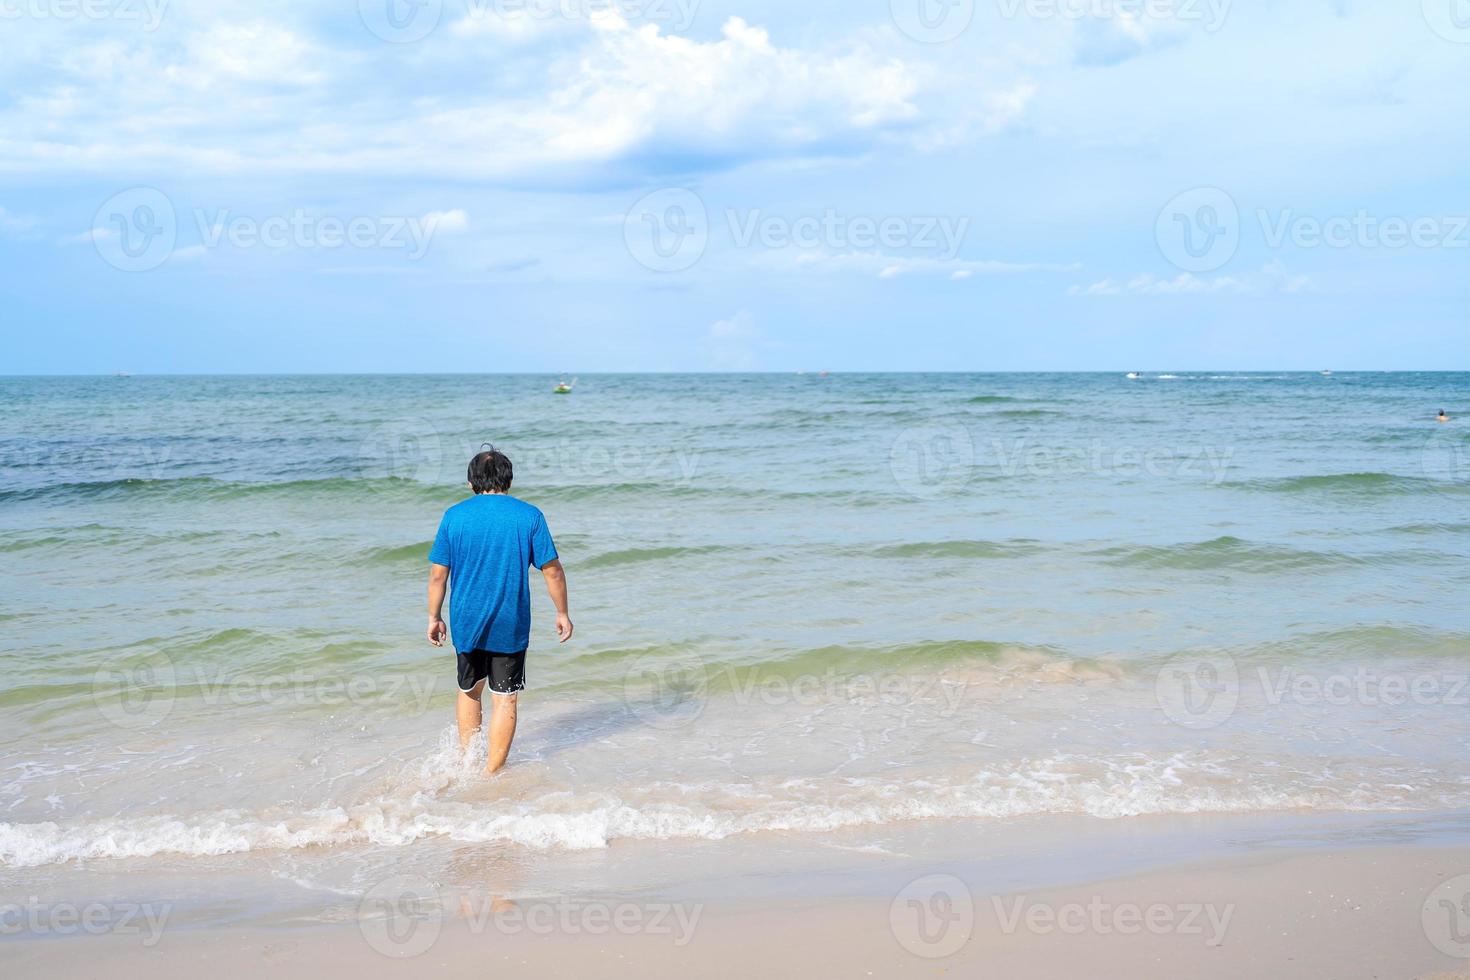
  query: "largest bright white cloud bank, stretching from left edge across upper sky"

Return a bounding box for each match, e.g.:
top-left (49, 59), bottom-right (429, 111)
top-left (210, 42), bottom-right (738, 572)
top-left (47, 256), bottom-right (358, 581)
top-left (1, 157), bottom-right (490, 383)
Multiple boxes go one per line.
top-left (0, 15), bottom-right (987, 179)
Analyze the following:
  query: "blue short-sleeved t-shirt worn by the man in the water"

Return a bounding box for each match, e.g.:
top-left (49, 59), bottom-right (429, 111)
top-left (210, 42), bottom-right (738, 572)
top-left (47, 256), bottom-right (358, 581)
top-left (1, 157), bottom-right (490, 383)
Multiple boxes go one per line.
top-left (429, 494), bottom-right (556, 654)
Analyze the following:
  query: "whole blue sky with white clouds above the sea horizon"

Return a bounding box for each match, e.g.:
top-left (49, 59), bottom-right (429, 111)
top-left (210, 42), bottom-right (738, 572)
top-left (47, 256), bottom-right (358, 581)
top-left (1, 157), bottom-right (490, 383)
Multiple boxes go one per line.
top-left (0, 0), bottom-right (1470, 373)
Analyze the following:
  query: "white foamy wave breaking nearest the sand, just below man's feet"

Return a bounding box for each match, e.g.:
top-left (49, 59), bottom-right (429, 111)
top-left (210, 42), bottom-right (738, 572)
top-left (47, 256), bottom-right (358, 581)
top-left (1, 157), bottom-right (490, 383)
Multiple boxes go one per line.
top-left (0, 752), bottom-right (1470, 868)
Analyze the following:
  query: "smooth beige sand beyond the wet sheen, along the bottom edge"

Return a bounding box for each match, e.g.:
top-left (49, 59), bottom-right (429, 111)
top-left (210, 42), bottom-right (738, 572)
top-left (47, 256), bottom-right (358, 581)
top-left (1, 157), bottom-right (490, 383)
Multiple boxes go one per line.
top-left (4, 845), bottom-right (1470, 980)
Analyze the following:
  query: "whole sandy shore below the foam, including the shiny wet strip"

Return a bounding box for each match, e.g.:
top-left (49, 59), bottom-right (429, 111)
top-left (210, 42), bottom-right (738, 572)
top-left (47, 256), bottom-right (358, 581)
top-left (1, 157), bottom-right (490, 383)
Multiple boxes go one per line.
top-left (4, 814), bottom-right (1470, 980)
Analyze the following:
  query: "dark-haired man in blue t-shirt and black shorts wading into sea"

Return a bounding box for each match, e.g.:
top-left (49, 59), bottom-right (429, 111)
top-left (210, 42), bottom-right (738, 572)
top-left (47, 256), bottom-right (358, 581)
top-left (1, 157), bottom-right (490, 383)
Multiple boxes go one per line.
top-left (429, 448), bottom-right (572, 773)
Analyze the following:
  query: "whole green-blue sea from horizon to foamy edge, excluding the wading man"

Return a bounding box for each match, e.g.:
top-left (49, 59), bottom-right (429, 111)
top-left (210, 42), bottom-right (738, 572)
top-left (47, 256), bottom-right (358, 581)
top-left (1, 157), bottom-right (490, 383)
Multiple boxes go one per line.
top-left (0, 370), bottom-right (1470, 922)
